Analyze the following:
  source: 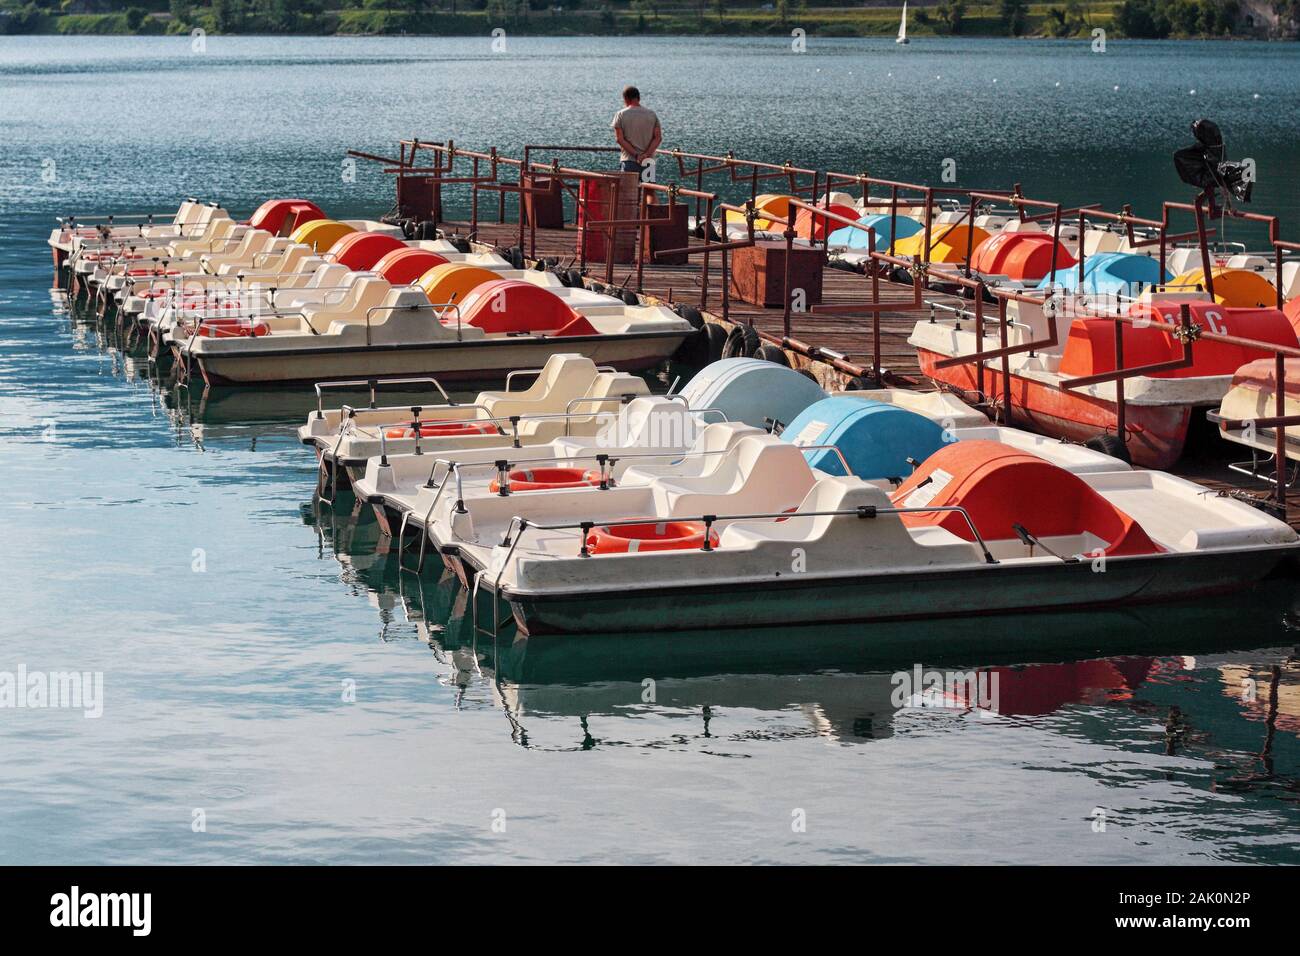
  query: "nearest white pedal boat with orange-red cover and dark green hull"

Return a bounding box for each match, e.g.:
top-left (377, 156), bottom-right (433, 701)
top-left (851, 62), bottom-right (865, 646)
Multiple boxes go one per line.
top-left (460, 436), bottom-right (1300, 636)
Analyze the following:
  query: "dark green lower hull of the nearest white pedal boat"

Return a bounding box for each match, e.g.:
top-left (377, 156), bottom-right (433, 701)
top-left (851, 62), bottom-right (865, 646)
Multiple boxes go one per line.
top-left (499, 546), bottom-right (1296, 634)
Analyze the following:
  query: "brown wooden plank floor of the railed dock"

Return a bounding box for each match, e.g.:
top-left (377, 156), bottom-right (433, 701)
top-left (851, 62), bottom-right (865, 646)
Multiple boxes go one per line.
top-left (442, 221), bottom-right (1300, 531)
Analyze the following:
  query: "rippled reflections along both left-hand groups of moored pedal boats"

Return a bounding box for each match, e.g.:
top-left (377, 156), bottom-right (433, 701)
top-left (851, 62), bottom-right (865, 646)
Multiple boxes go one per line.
top-left (38, 234), bottom-right (1300, 858)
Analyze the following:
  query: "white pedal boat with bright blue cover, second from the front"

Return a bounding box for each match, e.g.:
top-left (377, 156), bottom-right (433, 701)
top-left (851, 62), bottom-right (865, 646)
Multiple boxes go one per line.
top-left (400, 395), bottom-right (1127, 584)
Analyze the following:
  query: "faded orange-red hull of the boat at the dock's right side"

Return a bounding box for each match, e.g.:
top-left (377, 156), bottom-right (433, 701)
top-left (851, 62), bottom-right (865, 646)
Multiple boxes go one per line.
top-left (917, 349), bottom-right (1195, 471)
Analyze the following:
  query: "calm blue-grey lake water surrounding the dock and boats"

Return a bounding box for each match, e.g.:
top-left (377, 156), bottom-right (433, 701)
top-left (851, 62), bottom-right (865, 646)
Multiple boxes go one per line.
top-left (0, 38), bottom-right (1300, 864)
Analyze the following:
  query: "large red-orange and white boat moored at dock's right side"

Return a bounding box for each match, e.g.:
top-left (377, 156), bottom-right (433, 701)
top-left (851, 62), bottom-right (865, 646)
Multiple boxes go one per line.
top-left (907, 286), bottom-right (1297, 468)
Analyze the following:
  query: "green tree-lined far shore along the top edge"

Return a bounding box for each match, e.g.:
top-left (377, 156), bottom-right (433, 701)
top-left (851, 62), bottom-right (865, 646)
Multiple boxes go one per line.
top-left (0, 0), bottom-right (1279, 39)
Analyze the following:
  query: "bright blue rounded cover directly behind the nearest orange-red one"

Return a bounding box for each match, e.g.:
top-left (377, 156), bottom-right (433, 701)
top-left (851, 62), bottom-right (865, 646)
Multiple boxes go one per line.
top-left (781, 395), bottom-right (952, 480)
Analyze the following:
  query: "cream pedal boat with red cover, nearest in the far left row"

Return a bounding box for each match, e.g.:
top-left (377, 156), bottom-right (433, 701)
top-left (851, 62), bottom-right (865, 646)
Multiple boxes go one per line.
top-left (165, 273), bottom-right (694, 385)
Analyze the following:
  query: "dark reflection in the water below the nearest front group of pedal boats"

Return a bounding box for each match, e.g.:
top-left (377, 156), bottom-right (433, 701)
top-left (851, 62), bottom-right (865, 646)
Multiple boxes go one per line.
top-left (303, 496), bottom-right (1300, 792)
